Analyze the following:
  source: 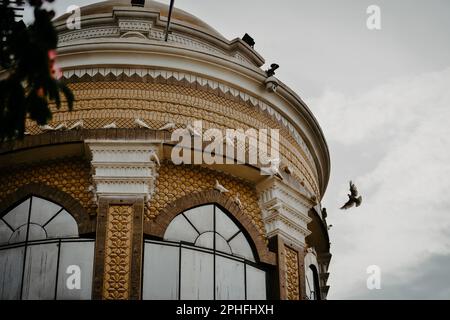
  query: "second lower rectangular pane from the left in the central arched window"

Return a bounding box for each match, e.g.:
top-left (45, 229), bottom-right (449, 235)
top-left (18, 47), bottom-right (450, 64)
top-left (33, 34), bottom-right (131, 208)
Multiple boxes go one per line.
top-left (181, 248), bottom-right (214, 300)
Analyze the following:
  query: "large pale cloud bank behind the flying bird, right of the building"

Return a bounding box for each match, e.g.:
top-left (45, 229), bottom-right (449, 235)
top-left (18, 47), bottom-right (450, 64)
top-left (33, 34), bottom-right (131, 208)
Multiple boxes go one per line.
top-left (309, 68), bottom-right (450, 298)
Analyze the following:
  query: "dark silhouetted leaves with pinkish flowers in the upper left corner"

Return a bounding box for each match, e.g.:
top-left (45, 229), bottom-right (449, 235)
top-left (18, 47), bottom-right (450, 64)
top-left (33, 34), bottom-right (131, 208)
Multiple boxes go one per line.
top-left (0, 0), bottom-right (74, 140)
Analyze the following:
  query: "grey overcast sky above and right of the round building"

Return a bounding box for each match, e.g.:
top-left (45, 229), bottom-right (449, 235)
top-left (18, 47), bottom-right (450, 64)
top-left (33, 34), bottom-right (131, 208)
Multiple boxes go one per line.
top-left (24, 0), bottom-right (450, 299)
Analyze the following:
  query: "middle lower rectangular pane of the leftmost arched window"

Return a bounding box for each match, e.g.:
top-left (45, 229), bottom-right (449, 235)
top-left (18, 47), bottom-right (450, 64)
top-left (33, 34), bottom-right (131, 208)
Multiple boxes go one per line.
top-left (22, 243), bottom-right (58, 300)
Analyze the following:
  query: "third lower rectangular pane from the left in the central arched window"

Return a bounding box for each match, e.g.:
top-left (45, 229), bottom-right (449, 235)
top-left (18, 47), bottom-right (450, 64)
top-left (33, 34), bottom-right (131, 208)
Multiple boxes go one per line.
top-left (216, 256), bottom-right (245, 300)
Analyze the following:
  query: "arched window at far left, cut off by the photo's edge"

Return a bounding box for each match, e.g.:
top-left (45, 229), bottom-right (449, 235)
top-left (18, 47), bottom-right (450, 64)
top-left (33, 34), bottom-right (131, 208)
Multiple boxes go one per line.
top-left (0, 196), bottom-right (94, 300)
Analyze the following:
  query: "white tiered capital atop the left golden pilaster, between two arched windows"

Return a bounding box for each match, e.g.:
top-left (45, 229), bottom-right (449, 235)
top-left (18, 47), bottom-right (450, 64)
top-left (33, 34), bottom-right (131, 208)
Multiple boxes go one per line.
top-left (86, 140), bottom-right (161, 201)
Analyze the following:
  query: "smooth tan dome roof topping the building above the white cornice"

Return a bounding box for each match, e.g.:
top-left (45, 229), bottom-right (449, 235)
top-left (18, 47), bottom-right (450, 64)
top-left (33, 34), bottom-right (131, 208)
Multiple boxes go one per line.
top-left (57, 0), bottom-right (223, 37)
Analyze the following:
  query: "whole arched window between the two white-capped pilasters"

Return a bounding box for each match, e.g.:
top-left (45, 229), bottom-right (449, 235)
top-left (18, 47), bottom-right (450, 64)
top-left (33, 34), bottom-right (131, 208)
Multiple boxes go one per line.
top-left (143, 204), bottom-right (266, 300)
